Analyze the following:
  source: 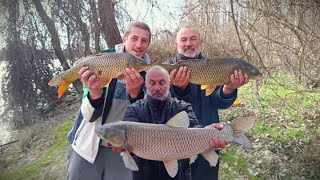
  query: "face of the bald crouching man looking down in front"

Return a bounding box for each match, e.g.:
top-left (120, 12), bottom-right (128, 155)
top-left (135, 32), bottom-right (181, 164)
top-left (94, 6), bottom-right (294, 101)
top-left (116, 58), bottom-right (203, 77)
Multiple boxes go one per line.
top-left (146, 70), bottom-right (170, 100)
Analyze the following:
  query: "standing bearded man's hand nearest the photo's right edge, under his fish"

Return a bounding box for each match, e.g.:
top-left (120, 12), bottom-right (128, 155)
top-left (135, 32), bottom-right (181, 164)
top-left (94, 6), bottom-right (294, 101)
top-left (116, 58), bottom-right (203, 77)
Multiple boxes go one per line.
top-left (223, 70), bottom-right (249, 94)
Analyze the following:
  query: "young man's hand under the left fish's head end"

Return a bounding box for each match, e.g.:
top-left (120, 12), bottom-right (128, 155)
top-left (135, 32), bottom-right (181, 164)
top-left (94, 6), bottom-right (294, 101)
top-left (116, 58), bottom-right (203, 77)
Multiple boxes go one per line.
top-left (123, 68), bottom-right (144, 99)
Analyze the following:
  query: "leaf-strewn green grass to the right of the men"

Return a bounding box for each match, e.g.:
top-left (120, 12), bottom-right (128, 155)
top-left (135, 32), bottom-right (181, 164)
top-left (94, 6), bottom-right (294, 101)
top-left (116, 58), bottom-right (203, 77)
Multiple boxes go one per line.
top-left (219, 71), bottom-right (320, 179)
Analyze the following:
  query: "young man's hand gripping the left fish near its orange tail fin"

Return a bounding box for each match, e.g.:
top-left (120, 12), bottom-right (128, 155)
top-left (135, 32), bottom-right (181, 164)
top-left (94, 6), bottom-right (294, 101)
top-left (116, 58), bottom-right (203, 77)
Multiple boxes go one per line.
top-left (79, 67), bottom-right (102, 100)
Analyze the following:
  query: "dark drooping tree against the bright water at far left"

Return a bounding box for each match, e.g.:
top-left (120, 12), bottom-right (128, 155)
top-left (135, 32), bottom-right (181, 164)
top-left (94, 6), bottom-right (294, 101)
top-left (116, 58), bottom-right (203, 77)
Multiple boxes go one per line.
top-left (2, 0), bottom-right (54, 126)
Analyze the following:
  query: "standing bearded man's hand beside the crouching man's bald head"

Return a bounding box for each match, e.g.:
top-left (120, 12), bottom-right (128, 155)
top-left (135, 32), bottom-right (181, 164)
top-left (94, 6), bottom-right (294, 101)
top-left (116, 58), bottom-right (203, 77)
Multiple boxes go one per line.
top-left (170, 66), bottom-right (191, 90)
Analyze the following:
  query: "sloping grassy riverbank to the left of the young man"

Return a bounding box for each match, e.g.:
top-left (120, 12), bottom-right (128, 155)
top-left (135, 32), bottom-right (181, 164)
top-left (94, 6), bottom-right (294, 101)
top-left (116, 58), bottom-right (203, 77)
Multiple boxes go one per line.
top-left (0, 97), bottom-right (80, 180)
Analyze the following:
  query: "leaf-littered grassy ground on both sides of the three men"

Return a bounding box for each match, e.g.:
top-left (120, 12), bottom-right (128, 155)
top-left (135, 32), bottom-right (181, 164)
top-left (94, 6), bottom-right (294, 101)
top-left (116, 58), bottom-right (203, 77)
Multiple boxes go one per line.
top-left (0, 76), bottom-right (320, 180)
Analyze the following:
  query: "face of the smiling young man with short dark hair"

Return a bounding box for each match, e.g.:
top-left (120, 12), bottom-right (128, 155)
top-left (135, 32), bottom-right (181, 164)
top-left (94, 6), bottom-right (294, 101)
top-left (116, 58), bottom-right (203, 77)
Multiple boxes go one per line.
top-left (122, 27), bottom-right (150, 58)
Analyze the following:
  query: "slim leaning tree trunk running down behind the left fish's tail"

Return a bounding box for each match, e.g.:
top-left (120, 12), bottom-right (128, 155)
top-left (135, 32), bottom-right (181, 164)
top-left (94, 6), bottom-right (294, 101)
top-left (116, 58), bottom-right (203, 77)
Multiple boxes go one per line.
top-left (32, 0), bottom-right (82, 93)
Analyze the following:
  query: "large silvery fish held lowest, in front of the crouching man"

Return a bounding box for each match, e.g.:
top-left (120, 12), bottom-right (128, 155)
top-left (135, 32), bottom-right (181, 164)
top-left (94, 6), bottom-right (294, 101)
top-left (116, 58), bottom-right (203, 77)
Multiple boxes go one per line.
top-left (96, 111), bottom-right (254, 177)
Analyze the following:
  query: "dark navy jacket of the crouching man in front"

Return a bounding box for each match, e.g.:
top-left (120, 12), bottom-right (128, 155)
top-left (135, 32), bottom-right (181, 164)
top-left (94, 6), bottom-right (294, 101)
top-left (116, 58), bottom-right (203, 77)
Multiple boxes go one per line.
top-left (124, 96), bottom-right (198, 180)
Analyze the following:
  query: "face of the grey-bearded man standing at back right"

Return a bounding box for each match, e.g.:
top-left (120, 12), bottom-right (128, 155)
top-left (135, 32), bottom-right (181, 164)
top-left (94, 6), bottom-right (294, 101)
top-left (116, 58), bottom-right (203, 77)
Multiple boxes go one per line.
top-left (176, 27), bottom-right (202, 58)
